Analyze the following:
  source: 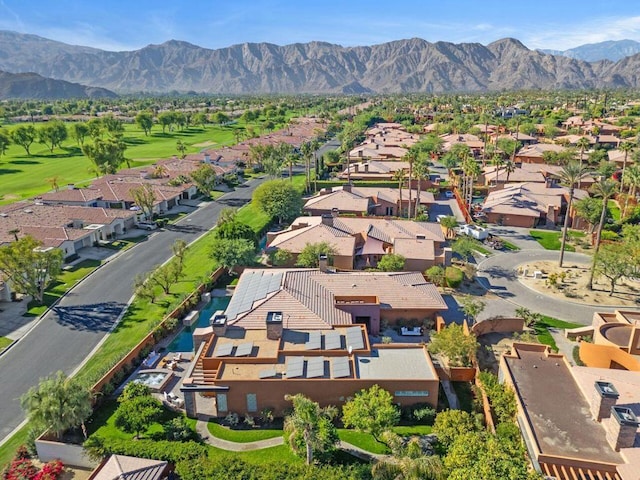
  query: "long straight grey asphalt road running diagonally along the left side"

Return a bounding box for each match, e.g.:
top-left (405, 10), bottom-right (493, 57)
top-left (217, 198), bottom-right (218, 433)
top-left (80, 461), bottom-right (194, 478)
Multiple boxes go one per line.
top-left (0, 179), bottom-right (264, 443)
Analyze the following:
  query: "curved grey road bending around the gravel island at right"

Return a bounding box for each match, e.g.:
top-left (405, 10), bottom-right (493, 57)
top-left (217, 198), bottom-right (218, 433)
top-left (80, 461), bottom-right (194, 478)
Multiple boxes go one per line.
top-left (477, 249), bottom-right (614, 325)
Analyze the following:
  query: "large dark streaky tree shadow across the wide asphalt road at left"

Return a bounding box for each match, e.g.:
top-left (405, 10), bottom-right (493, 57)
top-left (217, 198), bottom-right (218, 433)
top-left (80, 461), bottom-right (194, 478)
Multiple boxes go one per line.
top-left (52, 302), bottom-right (126, 332)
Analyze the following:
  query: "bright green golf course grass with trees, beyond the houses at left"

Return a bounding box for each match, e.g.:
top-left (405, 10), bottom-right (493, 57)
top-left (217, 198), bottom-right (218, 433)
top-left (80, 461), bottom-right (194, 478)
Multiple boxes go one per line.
top-left (0, 122), bottom-right (258, 204)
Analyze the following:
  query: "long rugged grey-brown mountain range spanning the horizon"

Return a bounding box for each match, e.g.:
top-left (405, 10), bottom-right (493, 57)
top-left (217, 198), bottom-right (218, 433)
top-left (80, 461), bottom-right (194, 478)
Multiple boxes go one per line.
top-left (0, 31), bottom-right (640, 94)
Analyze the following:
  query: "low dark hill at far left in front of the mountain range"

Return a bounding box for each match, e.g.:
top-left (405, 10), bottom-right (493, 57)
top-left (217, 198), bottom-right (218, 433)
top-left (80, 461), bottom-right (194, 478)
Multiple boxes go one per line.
top-left (0, 70), bottom-right (117, 100)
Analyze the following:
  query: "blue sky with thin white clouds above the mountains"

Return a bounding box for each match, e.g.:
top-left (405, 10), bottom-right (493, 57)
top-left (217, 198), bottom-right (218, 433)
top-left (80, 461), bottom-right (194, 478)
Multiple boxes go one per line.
top-left (0, 0), bottom-right (640, 50)
